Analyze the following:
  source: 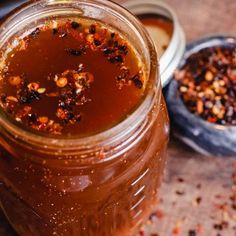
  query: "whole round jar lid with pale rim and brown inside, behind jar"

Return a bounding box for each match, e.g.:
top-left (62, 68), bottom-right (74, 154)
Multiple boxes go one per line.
top-left (122, 0), bottom-right (186, 87)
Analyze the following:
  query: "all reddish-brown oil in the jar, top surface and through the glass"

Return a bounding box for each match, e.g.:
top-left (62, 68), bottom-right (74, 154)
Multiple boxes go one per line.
top-left (0, 17), bottom-right (168, 236)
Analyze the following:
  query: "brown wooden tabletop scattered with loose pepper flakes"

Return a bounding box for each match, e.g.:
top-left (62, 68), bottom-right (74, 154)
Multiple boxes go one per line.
top-left (144, 0), bottom-right (236, 236)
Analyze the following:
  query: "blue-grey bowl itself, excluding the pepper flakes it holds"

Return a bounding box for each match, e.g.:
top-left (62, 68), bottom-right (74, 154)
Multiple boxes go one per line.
top-left (165, 36), bottom-right (236, 156)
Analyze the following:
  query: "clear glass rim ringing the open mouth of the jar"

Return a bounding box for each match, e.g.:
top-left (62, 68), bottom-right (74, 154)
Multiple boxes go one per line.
top-left (0, 0), bottom-right (161, 153)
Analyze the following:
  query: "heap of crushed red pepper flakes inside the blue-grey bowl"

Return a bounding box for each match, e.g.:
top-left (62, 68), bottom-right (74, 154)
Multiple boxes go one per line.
top-left (175, 46), bottom-right (236, 125)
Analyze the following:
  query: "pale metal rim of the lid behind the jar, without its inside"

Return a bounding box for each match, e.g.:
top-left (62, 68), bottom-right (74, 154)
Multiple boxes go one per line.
top-left (122, 0), bottom-right (186, 87)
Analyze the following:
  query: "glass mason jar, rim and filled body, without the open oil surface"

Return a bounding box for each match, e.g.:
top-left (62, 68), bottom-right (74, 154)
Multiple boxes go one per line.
top-left (0, 0), bottom-right (169, 236)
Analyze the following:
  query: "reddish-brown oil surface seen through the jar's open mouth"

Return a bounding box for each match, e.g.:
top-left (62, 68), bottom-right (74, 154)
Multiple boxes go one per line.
top-left (0, 18), bottom-right (144, 136)
